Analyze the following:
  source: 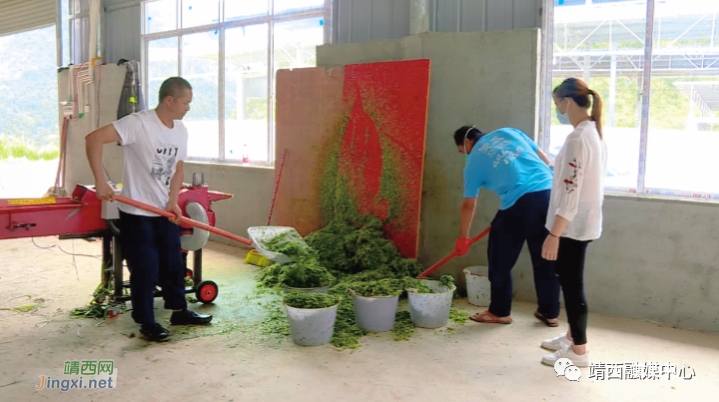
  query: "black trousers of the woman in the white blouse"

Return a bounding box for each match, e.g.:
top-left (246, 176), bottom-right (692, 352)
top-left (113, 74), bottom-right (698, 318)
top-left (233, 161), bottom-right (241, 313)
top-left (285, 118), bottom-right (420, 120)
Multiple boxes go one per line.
top-left (554, 237), bottom-right (590, 345)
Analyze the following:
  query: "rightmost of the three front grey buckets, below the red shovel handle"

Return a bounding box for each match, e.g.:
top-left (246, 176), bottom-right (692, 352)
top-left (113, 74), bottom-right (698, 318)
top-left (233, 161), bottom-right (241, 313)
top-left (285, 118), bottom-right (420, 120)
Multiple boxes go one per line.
top-left (407, 281), bottom-right (457, 328)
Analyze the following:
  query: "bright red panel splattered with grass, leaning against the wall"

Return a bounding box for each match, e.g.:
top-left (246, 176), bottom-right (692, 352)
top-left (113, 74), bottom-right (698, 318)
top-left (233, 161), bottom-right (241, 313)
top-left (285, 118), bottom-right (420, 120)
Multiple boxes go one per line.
top-left (338, 60), bottom-right (430, 258)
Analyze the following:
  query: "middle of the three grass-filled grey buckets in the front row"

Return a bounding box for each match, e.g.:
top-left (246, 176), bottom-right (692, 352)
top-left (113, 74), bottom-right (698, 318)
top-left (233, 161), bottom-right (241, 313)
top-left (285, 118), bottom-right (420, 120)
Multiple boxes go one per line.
top-left (349, 279), bottom-right (404, 332)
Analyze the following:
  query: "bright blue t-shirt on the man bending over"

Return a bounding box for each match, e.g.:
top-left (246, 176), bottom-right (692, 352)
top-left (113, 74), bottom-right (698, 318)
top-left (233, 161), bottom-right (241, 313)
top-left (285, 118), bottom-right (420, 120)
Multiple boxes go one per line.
top-left (464, 128), bottom-right (552, 210)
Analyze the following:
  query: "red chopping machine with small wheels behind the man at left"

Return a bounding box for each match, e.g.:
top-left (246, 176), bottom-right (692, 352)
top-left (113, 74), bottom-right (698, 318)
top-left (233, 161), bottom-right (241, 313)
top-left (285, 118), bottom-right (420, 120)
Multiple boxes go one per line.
top-left (0, 174), bottom-right (232, 303)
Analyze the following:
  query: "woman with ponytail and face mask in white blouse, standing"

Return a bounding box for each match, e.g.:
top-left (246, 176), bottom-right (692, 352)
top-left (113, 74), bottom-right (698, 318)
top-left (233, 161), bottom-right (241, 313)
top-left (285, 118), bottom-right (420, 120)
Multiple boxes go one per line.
top-left (542, 78), bottom-right (607, 367)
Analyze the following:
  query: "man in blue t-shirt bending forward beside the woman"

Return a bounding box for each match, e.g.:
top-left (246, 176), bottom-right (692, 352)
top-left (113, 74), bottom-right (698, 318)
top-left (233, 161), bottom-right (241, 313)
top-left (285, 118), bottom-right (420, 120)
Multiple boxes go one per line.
top-left (454, 126), bottom-right (559, 327)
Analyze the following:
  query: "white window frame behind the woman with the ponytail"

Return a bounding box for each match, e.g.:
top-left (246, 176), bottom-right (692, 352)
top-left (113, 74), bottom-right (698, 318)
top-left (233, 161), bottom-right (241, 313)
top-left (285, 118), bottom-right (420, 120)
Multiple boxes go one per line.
top-left (537, 0), bottom-right (719, 202)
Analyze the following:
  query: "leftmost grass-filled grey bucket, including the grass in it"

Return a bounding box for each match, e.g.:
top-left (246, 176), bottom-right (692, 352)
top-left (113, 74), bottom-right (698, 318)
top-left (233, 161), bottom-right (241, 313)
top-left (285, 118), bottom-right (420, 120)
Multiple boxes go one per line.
top-left (282, 292), bottom-right (341, 346)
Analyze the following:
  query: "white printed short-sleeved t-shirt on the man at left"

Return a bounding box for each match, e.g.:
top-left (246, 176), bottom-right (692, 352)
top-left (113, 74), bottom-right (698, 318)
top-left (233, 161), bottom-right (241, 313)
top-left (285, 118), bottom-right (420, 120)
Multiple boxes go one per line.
top-left (113, 110), bottom-right (187, 216)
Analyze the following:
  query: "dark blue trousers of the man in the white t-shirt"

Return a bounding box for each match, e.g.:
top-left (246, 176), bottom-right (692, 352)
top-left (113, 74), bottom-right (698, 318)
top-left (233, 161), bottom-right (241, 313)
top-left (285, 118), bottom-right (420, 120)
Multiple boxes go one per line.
top-left (116, 212), bottom-right (187, 324)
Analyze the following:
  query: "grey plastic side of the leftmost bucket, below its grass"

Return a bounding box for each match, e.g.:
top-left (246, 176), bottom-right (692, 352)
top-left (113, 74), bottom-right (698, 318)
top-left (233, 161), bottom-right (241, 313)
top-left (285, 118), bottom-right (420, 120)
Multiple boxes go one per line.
top-left (285, 303), bottom-right (339, 346)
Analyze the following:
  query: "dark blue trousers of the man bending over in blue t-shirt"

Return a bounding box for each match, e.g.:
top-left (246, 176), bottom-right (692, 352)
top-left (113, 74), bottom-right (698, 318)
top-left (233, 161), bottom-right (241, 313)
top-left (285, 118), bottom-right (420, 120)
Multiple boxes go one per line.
top-left (488, 190), bottom-right (559, 318)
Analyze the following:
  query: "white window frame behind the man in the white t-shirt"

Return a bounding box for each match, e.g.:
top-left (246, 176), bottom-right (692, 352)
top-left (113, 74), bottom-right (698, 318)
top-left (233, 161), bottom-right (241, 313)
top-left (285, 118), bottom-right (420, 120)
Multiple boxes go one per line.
top-left (140, 0), bottom-right (333, 167)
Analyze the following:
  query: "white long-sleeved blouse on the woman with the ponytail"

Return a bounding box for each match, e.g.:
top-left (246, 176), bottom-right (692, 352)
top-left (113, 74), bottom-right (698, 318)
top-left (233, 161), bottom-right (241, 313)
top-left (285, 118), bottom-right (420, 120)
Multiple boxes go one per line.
top-left (547, 121), bottom-right (607, 241)
